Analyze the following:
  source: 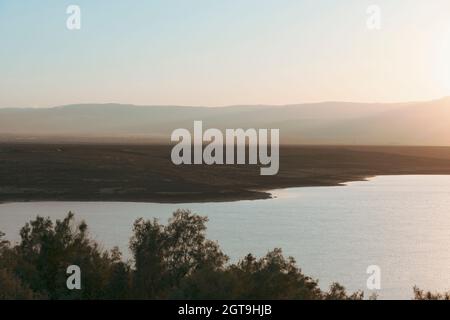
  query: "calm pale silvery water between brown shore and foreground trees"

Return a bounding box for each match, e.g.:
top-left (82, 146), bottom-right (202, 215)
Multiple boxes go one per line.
top-left (0, 176), bottom-right (450, 299)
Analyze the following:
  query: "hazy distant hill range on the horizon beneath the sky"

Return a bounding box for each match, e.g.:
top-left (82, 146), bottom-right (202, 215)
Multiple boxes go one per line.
top-left (0, 98), bottom-right (450, 145)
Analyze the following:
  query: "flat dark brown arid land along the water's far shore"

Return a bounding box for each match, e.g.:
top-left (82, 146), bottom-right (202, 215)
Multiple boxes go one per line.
top-left (0, 143), bottom-right (450, 202)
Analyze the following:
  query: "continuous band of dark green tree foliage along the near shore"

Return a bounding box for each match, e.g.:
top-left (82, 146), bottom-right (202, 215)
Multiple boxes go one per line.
top-left (0, 210), bottom-right (363, 300)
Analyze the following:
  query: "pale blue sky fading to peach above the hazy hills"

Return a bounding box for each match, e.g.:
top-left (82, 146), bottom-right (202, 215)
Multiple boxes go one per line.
top-left (0, 0), bottom-right (450, 107)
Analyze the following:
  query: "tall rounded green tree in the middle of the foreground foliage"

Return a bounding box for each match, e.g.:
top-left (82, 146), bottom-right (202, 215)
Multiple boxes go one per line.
top-left (130, 210), bottom-right (228, 299)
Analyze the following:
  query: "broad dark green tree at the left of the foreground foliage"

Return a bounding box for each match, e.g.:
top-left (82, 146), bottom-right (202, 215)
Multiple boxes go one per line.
top-left (13, 213), bottom-right (129, 299)
